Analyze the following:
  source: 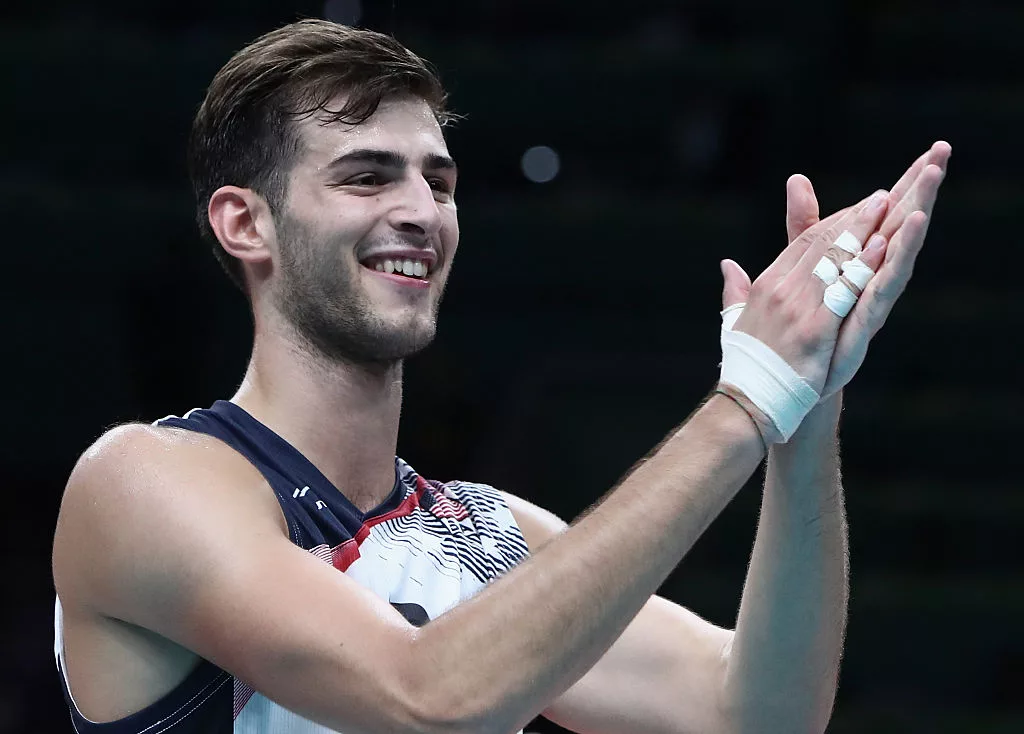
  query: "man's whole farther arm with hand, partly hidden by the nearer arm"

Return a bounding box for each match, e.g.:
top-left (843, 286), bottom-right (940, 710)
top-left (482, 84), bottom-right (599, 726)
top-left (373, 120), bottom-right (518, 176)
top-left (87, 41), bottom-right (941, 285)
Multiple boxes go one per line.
top-left (483, 142), bottom-right (949, 734)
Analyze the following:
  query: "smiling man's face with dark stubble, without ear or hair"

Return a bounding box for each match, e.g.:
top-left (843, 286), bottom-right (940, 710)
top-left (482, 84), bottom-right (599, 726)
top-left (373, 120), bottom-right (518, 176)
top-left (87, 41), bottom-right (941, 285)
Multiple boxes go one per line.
top-left (271, 98), bottom-right (459, 363)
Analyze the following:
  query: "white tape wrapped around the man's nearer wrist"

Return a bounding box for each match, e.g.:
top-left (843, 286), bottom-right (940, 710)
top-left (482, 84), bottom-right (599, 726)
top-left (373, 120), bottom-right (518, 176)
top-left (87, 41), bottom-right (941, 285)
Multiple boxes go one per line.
top-left (719, 303), bottom-right (819, 443)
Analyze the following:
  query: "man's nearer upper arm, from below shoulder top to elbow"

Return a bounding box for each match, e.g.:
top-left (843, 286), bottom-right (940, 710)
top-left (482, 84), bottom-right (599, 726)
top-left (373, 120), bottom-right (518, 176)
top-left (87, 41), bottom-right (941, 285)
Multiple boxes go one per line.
top-left (54, 423), bottom-right (423, 732)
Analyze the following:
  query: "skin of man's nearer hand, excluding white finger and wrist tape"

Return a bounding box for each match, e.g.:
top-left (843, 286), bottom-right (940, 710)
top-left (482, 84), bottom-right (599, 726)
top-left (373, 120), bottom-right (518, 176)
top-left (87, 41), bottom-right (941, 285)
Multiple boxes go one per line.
top-left (722, 191), bottom-right (889, 393)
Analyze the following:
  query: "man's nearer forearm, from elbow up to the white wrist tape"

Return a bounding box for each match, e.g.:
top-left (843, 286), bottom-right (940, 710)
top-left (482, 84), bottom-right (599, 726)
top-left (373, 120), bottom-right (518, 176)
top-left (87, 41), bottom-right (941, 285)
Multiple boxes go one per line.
top-left (417, 395), bottom-right (763, 731)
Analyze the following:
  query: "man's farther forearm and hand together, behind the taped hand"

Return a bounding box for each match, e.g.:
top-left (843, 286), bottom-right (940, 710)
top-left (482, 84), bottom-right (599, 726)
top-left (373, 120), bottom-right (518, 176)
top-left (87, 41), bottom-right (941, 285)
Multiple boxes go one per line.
top-left (723, 141), bottom-right (950, 732)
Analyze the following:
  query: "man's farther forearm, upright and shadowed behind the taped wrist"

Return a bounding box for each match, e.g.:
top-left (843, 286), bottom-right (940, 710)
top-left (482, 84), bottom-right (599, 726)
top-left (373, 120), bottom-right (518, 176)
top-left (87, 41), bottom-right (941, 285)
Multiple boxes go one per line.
top-left (726, 395), bottom-right (848, 732)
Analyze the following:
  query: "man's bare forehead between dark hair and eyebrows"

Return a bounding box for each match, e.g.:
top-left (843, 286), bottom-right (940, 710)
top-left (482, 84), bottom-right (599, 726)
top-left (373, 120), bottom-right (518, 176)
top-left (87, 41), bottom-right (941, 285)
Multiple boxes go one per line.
top-left (300, 97), bottom-right (447, 165)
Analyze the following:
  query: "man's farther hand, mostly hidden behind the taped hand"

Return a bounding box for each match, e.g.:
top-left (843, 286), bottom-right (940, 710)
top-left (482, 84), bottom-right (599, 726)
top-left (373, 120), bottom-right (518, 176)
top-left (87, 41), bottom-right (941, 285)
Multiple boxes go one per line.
top-left (722, 141), bottom-right (951, 400)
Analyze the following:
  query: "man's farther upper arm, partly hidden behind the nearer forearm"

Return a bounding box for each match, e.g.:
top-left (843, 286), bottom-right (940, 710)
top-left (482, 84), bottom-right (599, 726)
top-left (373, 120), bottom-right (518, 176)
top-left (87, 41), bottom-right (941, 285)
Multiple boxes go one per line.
top-left (506, 494), bottom-right (732, 734)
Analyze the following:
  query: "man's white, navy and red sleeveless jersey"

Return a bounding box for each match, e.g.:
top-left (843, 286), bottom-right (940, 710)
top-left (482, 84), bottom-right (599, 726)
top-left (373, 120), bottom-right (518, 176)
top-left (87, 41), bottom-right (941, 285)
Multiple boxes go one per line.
top-left (54, 400), bottom-right (527, 734)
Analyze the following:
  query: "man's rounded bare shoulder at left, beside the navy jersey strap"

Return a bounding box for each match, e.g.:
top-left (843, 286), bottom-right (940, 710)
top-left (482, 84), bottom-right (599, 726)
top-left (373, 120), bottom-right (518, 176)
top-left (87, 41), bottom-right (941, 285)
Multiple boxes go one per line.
top-left (52, 417), bottom-right (283, 616)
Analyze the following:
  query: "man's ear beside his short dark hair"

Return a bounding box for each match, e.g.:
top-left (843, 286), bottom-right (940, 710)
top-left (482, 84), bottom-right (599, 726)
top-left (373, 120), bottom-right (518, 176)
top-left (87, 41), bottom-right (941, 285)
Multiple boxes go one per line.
top-left (206, 186), bottom-right (275, 264)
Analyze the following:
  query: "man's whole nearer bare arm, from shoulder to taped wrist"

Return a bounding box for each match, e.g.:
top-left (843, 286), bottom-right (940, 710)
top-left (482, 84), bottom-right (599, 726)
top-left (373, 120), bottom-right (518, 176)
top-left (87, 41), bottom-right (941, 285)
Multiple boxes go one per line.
top-left (54, 396), bottom-right (762, 732)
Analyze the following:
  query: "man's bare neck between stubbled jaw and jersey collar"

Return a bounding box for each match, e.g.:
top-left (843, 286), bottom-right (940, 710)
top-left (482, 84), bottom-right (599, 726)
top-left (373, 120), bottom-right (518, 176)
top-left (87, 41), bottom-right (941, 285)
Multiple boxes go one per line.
top-left (231, 317), bottom-right (401, 512)
